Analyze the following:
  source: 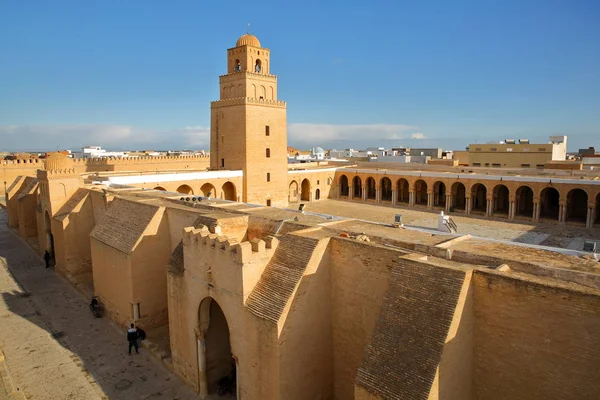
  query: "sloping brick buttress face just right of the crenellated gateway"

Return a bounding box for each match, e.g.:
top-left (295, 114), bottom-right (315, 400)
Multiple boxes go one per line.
top-left (246, 235), bottom-right (319, 323)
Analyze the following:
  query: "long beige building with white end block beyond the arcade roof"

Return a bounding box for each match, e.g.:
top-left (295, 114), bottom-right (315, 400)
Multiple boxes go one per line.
top-left (468, 136), bottom-right (567, 168)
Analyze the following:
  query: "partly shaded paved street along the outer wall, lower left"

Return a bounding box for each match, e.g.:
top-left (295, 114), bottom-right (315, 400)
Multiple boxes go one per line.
top-left (0, 208), bottom-right (198, 400)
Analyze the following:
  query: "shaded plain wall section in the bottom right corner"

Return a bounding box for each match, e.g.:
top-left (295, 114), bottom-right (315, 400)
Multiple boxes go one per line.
top-left (473, 270), bottom-right (600, 400)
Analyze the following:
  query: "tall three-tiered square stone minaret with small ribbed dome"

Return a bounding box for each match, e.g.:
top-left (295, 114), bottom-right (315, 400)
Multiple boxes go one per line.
top-left (210, 34), bottom-right (288, 207)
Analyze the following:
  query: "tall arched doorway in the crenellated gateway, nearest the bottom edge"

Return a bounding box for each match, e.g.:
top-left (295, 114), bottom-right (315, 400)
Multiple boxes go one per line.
top-left (196, 297), bottom-right (237, 396)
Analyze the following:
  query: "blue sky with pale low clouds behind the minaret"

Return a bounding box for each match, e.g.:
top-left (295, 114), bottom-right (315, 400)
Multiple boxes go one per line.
top-left (0, 0), bottom-right (600, 150)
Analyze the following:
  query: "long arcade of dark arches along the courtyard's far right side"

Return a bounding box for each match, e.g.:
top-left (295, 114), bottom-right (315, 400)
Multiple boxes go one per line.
top-left (332, 173), bottom-right (600, 227)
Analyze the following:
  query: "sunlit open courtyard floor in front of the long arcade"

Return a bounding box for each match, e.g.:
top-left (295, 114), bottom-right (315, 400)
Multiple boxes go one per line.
top-left (304, 200), bottom-right (600, 251)
